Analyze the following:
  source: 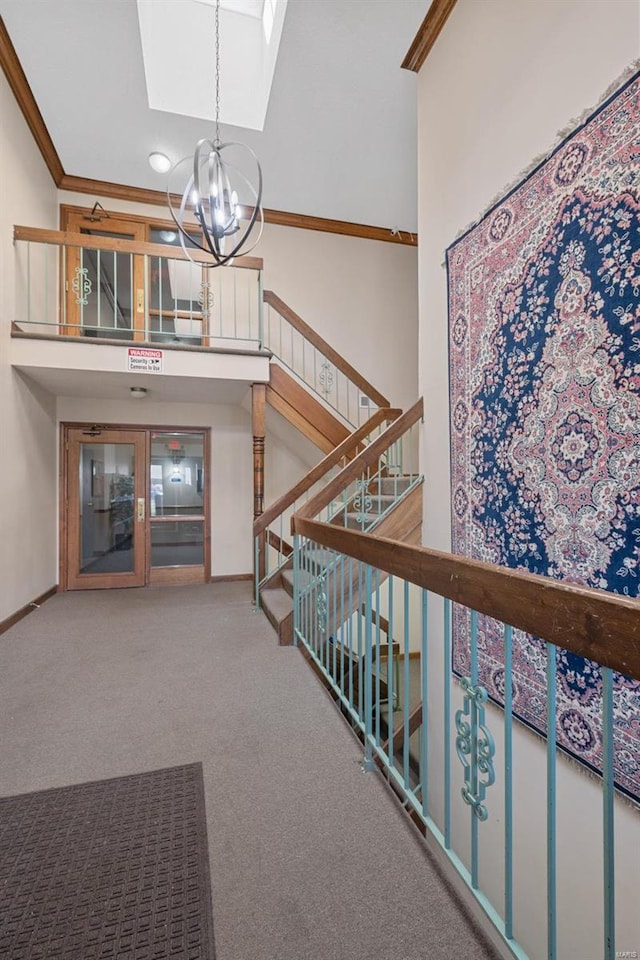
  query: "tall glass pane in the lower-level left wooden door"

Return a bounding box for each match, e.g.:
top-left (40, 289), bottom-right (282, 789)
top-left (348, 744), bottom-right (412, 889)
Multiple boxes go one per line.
top-left (80, 443), bottom-right (134, 573)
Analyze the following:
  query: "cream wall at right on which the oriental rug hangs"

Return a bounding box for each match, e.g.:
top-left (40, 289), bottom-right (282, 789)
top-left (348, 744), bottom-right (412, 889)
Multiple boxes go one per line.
top-left (418, 0), bottom-right (640, 960)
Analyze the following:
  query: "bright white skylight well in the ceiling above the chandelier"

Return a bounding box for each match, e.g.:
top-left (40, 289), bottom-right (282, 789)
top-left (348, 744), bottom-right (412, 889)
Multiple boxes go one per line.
top-left (137, 0), bottom-right (287, 130)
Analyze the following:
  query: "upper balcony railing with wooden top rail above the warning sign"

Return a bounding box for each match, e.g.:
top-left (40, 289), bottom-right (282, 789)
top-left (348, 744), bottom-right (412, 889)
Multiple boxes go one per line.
top-left (14, 227), bottom-right (263, 351)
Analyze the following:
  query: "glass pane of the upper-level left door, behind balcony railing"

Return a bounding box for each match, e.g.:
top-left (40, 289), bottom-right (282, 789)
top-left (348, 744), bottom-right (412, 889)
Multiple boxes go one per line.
top-left (79, 229), bottom-right (133, 340)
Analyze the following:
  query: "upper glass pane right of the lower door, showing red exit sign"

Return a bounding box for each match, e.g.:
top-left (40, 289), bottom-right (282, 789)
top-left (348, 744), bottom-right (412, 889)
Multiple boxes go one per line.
top-left (150, 432), bottom-right (204, 517)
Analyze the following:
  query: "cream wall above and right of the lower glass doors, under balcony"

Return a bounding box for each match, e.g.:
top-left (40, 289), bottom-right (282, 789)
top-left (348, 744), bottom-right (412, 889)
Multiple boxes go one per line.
top-left (57, 397), bottom-right (253, 577)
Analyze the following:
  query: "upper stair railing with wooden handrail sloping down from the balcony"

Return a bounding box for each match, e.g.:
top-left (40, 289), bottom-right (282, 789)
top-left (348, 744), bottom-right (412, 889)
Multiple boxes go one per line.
top-left (264, 290), bottom-right (390, 427)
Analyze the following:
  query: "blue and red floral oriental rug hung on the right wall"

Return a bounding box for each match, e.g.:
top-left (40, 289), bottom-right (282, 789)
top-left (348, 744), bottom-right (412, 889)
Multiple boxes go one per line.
top-left (447, 74), bottom-right (640, 801)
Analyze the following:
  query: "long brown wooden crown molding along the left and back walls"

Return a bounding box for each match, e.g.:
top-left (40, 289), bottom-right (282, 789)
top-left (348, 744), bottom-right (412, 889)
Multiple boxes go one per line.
top-left (0, 18), bottom-right (420, 247)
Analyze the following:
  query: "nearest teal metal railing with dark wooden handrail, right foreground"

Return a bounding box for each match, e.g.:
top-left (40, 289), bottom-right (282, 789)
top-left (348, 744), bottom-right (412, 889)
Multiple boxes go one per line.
top-left (292, 516), bottom-right (640, 960)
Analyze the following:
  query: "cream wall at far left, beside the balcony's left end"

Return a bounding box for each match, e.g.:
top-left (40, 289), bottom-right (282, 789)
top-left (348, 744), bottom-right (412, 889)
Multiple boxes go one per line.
top-left (0, 72), bottom-right (58, 621)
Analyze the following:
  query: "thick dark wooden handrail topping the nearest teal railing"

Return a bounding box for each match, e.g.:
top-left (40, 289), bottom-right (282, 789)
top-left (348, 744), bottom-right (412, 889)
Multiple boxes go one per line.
top-left (291, 514), bottom-right (640, 680)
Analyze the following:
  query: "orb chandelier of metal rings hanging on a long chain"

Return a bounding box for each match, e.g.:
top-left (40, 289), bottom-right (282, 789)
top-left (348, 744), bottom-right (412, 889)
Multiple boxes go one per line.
top-left (167, 0), bottom-right (264, 267)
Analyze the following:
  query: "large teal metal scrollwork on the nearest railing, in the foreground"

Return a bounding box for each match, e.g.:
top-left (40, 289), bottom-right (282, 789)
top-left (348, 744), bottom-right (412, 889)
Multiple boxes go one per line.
top-left (456, 677), bottom-right (496, 820)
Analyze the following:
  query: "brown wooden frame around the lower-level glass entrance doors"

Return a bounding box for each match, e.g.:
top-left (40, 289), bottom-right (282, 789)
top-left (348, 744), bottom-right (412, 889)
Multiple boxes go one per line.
top-left (58, 420), bottom-right (211, 592)
